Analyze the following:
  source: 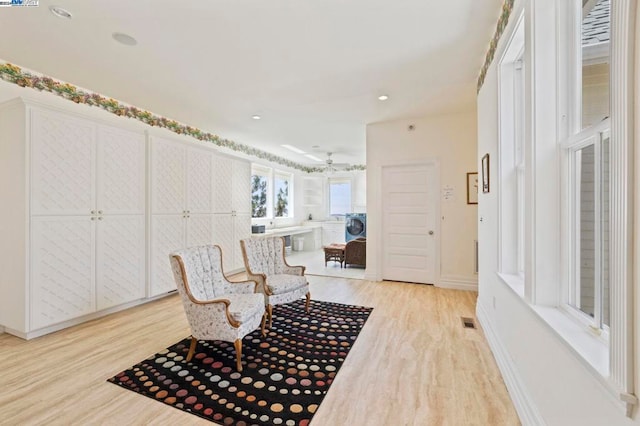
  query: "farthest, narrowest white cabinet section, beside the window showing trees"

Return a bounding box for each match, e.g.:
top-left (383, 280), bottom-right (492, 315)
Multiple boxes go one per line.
top-left (213, 156), bottom-right (251, 272)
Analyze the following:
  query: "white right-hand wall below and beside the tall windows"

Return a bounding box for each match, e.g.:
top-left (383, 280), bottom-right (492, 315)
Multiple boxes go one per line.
top-left (477, 1), bottom-right (640, 426)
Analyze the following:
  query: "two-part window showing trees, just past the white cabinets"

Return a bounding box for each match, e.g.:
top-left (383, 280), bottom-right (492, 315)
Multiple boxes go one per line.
top-left (251, 164), bottom-right (293, 219)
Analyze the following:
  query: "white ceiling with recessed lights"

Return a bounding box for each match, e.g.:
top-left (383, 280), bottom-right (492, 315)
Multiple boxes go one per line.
top-left (0, 0), bottom-right (502, 165)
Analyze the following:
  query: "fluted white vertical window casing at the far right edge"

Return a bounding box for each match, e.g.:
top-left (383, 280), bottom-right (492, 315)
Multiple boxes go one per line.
top-left (609, 0), bottom-right (638, 418)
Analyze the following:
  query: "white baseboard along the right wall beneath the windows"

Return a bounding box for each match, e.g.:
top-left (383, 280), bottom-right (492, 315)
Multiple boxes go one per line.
top-left (476, 300), bottom-right (546, 426)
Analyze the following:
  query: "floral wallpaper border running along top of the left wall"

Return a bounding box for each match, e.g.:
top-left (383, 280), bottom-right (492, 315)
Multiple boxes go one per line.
top-left (0, 63), bottom-right (366, 173)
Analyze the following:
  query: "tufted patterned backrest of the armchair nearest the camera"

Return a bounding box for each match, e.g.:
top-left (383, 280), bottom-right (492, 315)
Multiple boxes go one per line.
top-left (171, 245), bottom-right (225, 301)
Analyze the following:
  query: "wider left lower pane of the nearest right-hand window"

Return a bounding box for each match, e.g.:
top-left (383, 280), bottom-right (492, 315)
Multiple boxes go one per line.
top-left (576, 145), bottom-right (596, 317)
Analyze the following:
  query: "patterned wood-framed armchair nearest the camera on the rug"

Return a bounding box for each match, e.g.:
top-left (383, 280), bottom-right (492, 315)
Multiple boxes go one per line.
top-left (170, 245), bottom-right (266, 371)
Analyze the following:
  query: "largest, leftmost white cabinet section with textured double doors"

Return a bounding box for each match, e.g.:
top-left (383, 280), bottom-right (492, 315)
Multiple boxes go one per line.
top-left (0, 100), bottom-right (146, 337)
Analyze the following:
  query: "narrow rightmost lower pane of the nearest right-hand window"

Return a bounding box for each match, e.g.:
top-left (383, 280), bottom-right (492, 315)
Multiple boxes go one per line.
top-left (600, 137), bottom-right (610, 326)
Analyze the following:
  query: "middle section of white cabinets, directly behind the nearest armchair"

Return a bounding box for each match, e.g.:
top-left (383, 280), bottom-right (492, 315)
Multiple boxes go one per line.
top-left (149, 137), bottom-right (215, 296)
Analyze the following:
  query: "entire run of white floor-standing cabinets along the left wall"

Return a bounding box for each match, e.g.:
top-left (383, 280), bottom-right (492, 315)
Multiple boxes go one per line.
top-left (0, 99), bottom-right (251, 338)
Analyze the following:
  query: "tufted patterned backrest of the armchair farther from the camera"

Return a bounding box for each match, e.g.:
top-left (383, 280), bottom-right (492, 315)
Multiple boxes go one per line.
top-left (242, 237), bottom-right (285, 276)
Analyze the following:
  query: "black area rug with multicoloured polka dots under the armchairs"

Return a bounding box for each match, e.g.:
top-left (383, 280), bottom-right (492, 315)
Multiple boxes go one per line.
top-left (108, 300), bottom-right (372, 426)
